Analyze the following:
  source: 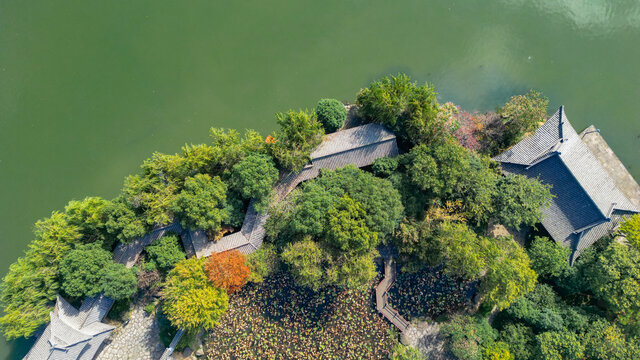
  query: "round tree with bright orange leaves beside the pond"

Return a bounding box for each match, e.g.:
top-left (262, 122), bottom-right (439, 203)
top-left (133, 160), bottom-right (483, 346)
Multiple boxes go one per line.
top-left (205, 250), bottom-right (251, 293)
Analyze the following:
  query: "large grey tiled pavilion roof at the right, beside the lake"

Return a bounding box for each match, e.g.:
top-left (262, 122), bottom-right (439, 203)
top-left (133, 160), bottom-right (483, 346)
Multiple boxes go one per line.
top-left (494, 107), bottom-right (640, 261)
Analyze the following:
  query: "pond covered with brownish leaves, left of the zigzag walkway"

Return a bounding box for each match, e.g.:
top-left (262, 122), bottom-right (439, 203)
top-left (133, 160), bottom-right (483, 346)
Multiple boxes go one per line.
top-left (206, 272), bottom-right (397, 360)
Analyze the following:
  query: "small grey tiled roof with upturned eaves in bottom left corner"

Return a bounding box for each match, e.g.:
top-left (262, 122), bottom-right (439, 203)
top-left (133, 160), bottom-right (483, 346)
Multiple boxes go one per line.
top-left (23, 295), bottom-right (114, 360)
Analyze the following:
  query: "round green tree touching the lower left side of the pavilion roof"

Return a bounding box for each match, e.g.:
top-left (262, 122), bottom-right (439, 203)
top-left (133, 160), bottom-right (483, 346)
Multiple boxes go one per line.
top-left (495, 175), bottom-right (552, 229)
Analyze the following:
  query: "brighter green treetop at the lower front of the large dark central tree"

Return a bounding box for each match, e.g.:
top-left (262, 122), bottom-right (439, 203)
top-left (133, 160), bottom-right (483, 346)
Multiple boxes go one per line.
top-left (324, 195), bottom-right (378, 253)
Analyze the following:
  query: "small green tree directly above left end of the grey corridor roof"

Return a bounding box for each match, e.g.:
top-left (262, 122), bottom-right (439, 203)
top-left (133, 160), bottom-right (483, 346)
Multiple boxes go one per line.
top-left (104, 198), bottom-right (149, 245)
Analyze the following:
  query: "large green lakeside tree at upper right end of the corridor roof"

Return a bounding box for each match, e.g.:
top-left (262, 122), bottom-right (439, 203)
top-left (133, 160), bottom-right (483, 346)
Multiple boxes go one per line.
top-left (356, 74), bottom-right (444, 145)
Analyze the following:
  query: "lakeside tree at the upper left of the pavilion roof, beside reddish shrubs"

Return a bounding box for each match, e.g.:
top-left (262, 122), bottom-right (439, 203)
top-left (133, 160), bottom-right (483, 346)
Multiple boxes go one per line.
top-left (498, 90), bottom-right (549, 146)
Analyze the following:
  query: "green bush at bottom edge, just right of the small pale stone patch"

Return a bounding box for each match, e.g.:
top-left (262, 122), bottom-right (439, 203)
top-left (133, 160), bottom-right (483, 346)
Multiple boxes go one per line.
top-left (440, 315), bottom-right (498, 360)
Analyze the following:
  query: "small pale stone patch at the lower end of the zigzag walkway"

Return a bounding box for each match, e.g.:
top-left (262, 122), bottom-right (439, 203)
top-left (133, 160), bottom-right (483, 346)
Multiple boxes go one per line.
top-left (400, 321), bottom-right (449, 360)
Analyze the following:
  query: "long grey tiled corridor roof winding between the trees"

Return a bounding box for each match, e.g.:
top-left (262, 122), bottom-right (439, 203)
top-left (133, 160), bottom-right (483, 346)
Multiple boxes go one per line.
top-left (185, 124), bottom-right (398, 257)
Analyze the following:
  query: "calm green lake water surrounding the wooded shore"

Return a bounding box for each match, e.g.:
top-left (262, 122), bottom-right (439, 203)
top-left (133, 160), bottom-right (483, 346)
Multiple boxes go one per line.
top-left (0, 0), bottom-right (640, 359)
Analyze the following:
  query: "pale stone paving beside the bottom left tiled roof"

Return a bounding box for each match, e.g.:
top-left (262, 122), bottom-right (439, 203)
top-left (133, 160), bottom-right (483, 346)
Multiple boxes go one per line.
top-left (96, 306), bottom-right (164, 360)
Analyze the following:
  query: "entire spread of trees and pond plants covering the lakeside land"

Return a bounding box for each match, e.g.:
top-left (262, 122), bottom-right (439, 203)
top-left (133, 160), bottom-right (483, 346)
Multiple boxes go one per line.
top-left (5, 75), bottom-right (640, 360)
